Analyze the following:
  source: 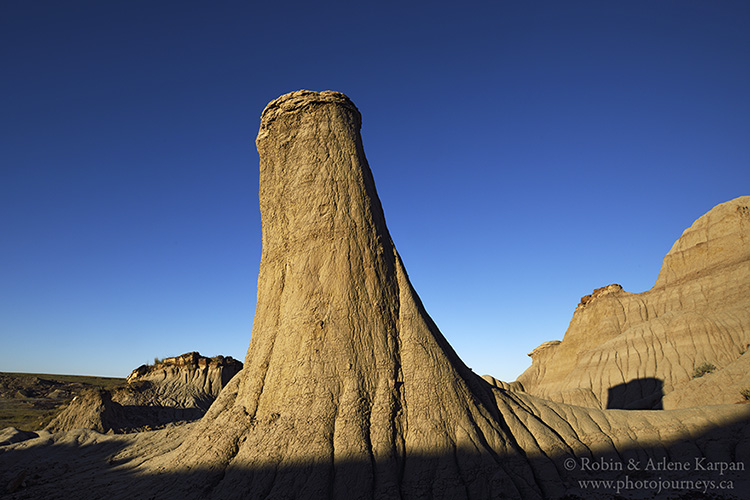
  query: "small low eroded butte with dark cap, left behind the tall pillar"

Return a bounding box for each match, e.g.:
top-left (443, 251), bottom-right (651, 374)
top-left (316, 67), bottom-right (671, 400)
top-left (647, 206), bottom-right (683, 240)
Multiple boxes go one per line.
top-left (45, 352), bottom-right (242, 432)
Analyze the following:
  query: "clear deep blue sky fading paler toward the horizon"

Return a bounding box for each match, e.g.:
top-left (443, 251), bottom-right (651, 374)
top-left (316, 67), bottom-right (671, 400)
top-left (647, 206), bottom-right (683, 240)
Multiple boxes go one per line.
top-left (0, 0), bottom-right (750, 380)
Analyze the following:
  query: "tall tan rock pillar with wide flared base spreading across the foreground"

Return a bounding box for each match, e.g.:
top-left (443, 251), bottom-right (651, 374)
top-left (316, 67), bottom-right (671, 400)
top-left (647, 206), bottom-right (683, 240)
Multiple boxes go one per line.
top-left (0, 91), bottom-right (750, 500)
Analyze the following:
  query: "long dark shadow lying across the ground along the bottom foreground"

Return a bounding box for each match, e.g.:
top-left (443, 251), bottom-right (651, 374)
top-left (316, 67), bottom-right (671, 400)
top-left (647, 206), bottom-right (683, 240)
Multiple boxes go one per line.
top-left (0, 410), bottom-right (750, 500)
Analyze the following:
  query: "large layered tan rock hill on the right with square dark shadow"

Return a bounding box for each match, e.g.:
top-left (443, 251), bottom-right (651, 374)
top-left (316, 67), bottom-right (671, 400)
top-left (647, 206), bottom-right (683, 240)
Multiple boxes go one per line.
top-left (518, 196), bottom-right (750, 409)
